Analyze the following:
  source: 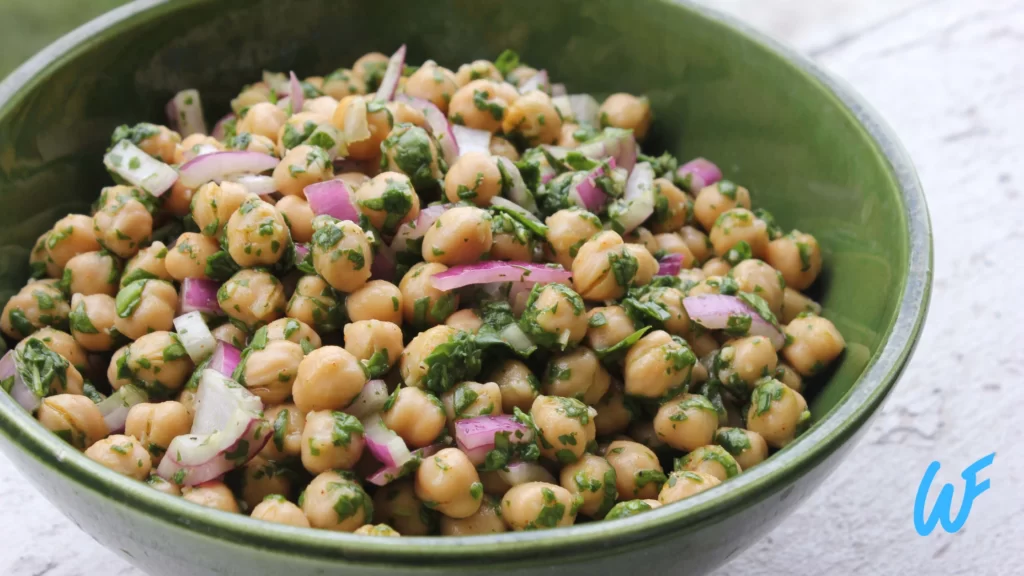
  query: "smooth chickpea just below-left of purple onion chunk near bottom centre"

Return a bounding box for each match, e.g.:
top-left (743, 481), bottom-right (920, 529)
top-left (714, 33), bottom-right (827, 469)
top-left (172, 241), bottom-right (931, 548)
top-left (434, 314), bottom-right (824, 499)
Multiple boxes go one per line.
top-left (415, 448), bottom-right (483, 519)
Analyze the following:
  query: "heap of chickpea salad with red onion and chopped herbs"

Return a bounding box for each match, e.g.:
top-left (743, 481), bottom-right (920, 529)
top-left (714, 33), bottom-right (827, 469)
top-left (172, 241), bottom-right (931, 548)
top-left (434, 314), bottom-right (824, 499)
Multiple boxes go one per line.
top-left (0, 46), bottom-right (846, 536)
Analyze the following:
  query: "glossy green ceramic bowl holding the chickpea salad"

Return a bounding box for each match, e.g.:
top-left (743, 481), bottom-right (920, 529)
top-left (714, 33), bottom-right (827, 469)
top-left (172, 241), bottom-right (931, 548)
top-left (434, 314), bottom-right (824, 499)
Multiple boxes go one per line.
top-left (0, 0), bottom-right (932, 576)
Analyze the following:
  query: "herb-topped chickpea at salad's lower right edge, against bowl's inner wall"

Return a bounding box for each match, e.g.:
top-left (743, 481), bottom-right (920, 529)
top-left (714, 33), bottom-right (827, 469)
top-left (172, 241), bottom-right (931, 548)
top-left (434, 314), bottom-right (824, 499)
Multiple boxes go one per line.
top-left (746, 378), bottom-right (811, 448)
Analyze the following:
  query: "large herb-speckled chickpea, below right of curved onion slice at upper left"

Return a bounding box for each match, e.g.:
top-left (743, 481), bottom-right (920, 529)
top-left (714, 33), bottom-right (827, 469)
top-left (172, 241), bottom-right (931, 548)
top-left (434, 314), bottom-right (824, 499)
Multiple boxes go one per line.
top-left (224, 195), bottom-right (292, 272)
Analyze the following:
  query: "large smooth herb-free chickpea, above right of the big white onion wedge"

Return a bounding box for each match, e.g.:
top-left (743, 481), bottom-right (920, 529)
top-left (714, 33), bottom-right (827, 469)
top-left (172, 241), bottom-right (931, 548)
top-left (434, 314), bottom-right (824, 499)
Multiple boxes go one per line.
top-left (292, 346), bottom-right (367, 412)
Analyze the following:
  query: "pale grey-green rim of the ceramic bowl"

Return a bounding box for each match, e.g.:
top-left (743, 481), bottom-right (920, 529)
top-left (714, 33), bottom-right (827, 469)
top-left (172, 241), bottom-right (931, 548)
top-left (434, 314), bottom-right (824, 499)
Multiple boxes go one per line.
top-left (0, 0), bottom-right (933, 566)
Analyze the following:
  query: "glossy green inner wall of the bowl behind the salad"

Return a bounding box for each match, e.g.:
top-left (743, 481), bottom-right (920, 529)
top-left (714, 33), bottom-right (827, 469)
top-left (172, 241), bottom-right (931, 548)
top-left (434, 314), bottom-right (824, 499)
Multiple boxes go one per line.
top-left (0, 0), bottom-right (927, 557)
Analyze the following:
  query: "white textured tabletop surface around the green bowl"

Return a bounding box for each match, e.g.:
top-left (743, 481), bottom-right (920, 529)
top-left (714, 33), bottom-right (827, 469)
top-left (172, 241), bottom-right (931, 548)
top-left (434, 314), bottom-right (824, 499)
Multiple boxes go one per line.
top-left (0, 0), bottom-right (1024, 576)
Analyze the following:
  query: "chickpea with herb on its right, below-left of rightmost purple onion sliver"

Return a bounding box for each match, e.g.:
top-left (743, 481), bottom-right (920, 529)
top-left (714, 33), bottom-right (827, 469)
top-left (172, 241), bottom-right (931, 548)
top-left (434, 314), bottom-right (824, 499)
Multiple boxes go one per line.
top-left (624, 330), bottom-right (696, 398)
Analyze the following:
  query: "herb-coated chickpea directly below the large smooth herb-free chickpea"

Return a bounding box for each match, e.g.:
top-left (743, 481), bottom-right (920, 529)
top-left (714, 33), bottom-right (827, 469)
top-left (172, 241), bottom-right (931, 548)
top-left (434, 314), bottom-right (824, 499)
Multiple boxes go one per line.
top-left (302, 410), bottom-right (366, 475)
